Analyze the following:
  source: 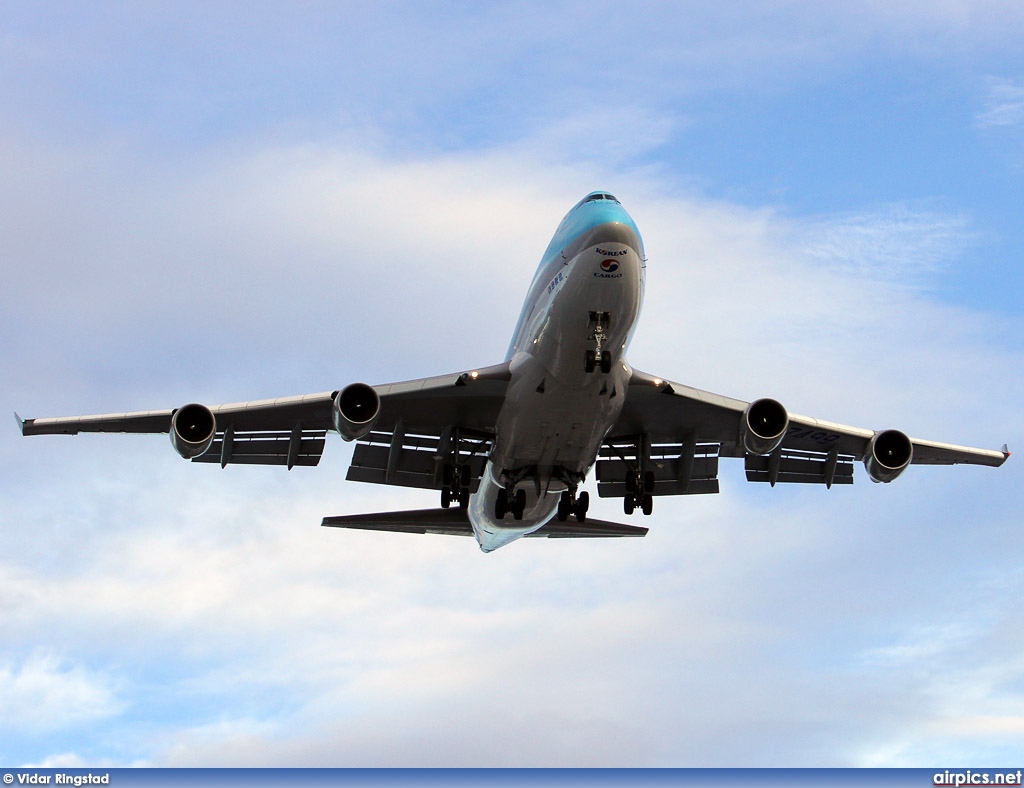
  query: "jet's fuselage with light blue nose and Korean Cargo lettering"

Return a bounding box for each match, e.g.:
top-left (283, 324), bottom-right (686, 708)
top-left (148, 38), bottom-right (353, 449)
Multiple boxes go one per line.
top-left (469, 192), bottom-right (644, 552)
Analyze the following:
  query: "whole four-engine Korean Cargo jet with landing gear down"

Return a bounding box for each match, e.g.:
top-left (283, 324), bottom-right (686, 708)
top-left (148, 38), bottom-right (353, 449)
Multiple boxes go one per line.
top-left (15, 191), bottom-right (1010, 553)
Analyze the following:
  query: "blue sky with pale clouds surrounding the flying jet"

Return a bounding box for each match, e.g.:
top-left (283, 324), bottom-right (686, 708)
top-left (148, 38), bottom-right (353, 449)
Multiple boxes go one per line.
top-left (0, 0), bottom-right (1024, 768)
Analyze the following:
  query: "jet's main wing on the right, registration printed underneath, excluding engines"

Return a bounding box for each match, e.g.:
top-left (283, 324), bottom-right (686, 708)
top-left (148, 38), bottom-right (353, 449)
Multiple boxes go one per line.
top-left (597, 369), bottom-right (1010, 496)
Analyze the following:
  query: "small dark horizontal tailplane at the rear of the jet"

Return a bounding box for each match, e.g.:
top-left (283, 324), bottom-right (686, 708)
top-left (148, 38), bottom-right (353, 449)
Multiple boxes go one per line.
top-left (321, 509), bottom-right (647, 539)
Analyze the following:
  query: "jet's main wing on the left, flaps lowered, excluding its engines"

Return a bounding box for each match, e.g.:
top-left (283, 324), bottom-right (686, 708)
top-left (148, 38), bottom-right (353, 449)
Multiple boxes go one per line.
top-left (15, 363), bottom-right (509, 472)
